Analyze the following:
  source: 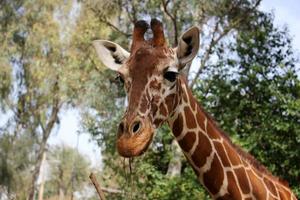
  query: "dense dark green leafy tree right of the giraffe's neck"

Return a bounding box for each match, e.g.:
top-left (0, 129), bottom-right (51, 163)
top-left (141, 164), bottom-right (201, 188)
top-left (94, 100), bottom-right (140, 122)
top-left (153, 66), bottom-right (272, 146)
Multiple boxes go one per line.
top-left (195, 13), bottom-right (300, 195)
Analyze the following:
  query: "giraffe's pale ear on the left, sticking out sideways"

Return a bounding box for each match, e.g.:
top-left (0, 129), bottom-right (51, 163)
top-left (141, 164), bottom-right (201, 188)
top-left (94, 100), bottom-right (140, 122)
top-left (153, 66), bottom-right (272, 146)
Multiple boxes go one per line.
top-left (93, 40), bottom-right (129, 71)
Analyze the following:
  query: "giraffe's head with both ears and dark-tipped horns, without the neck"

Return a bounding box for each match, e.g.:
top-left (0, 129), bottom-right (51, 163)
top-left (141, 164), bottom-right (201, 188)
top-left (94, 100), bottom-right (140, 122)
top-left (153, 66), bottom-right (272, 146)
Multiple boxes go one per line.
top-left (93, 19), bottom-right (199, 157)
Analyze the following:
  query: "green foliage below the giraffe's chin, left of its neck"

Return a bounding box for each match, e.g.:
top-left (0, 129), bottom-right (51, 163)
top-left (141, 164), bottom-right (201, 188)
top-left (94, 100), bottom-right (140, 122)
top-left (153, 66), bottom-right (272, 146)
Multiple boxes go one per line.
top-left (88, 126), bottom-right (208, 200)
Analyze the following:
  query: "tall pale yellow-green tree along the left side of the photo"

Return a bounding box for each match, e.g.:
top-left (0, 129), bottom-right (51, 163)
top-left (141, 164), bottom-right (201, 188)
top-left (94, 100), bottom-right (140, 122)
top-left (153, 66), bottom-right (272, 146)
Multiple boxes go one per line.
top-left (0, 1), bottom-right (111, 199)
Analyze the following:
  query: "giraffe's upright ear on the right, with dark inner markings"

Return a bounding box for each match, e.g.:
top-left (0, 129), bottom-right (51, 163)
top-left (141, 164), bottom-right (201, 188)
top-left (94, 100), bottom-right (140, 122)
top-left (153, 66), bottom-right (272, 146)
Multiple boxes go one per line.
top-left (177, 26), bottom-right (200, 70)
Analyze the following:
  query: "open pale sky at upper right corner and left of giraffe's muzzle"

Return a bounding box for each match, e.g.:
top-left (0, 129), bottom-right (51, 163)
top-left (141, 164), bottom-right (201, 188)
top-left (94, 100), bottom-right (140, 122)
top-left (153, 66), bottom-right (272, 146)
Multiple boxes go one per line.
top-left (49, 0), bottom-right (300, 169)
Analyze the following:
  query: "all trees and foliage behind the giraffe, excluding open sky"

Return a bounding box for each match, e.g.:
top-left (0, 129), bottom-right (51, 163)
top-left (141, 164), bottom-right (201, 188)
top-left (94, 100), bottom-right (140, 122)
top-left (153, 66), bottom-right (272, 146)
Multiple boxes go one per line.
top-left (0, 0), bottom-right (300, 200)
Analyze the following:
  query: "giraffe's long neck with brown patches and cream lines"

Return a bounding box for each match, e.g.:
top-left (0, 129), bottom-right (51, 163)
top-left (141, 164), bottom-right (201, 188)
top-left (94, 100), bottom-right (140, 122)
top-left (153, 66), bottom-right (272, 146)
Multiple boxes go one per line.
top-left (168, 77), bottom-right (296, 199)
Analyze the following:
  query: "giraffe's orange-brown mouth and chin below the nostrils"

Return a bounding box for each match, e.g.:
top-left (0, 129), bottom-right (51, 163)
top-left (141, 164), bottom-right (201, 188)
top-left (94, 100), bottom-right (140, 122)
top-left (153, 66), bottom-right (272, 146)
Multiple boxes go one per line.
top-left (117, 120), bottom-right (154, 158)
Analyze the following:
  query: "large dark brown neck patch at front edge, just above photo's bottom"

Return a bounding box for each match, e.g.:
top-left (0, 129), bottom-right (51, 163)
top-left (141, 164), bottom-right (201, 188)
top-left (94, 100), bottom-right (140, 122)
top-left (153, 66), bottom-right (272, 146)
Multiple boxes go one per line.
top-left (203, 156), bottom-right (224, 194)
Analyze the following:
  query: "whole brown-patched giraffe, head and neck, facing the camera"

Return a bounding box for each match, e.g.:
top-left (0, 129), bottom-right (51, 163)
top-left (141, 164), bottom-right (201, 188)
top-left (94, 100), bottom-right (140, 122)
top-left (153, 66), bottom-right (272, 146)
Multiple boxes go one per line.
top-left (93, 19), bottom-right (296, 200)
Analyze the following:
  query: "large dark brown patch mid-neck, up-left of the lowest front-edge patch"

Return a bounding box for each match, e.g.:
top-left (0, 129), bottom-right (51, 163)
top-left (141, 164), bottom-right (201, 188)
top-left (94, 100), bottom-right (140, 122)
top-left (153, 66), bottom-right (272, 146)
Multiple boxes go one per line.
top-left (192, 132), bottom-right (212, 168)
